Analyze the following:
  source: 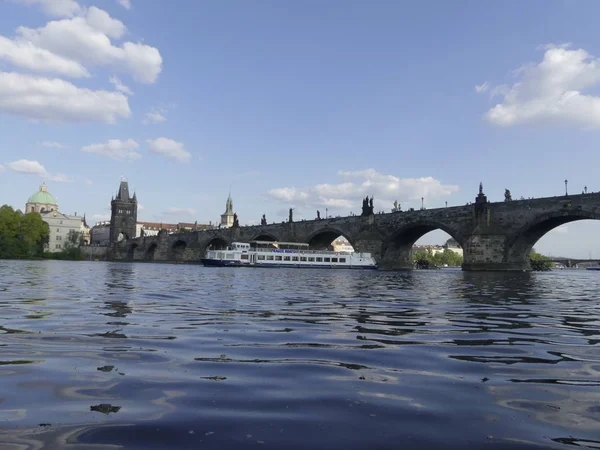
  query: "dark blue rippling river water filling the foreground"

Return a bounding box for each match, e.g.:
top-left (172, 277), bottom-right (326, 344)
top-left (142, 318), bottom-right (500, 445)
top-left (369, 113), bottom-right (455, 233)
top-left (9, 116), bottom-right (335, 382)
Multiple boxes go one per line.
top-left (0, 261), bottom-right (600, 450)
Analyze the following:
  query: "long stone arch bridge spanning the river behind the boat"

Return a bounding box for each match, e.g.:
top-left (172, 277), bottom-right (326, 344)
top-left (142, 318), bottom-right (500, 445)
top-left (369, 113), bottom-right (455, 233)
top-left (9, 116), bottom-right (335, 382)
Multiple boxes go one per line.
top-left (111, 187), bottom-right (600, 271)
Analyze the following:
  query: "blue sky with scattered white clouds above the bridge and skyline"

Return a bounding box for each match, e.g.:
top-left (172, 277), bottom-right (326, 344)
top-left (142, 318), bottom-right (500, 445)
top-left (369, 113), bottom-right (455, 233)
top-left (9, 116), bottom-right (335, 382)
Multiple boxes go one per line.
top-left (0, 0), bottom-right (600, 258)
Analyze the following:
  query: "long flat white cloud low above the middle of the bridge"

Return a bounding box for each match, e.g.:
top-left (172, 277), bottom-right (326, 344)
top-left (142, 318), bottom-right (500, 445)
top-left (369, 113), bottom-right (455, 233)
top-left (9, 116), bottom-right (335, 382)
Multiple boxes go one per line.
top-left (268, 169), bottom-right (458, 213)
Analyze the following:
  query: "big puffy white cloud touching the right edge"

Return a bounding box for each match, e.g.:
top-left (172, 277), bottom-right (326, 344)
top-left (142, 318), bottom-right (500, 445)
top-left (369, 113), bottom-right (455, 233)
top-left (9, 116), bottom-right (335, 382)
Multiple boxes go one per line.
top-left (485, 45), bottom-right (600, 127)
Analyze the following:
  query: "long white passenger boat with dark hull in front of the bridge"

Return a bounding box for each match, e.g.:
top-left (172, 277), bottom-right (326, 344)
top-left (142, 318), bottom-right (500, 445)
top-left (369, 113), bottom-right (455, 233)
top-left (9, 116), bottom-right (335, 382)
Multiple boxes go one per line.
top-left (202, 241), bottom-right (377, 269)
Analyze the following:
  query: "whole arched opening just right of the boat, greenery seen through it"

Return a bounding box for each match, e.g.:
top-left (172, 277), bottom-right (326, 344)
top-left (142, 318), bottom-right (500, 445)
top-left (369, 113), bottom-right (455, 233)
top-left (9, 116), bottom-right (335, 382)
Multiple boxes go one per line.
top-left (379, 223), bottom-right (463, 270)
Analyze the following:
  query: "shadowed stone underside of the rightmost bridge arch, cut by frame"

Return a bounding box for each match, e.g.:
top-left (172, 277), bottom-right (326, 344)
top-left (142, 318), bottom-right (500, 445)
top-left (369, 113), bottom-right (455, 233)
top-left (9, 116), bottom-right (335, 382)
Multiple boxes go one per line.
top-left (504, 205), bottom-right (600, 269)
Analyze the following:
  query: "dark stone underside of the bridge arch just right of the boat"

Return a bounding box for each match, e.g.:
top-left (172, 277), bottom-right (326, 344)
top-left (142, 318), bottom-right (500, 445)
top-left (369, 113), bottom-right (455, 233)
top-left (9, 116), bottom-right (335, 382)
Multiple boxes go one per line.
top-left (379, 220), bottom-right (464, 270)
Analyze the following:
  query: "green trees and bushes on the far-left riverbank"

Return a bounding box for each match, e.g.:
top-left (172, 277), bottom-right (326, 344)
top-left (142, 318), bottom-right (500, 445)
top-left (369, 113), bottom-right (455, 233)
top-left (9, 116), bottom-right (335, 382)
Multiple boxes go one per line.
top-left (0, 205), bottom-right (82, 259)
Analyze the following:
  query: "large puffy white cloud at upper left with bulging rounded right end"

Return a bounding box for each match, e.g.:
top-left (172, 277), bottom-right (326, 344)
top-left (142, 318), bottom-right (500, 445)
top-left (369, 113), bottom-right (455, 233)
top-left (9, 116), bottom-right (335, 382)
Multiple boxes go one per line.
top-left (17, 6), bottom-right (162, 83)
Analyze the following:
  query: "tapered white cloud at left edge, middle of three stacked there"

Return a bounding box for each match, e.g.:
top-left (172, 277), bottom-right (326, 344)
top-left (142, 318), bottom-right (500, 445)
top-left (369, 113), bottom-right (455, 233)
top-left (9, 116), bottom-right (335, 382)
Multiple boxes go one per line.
top-left (0, 36), bottom-right (90, 78)
